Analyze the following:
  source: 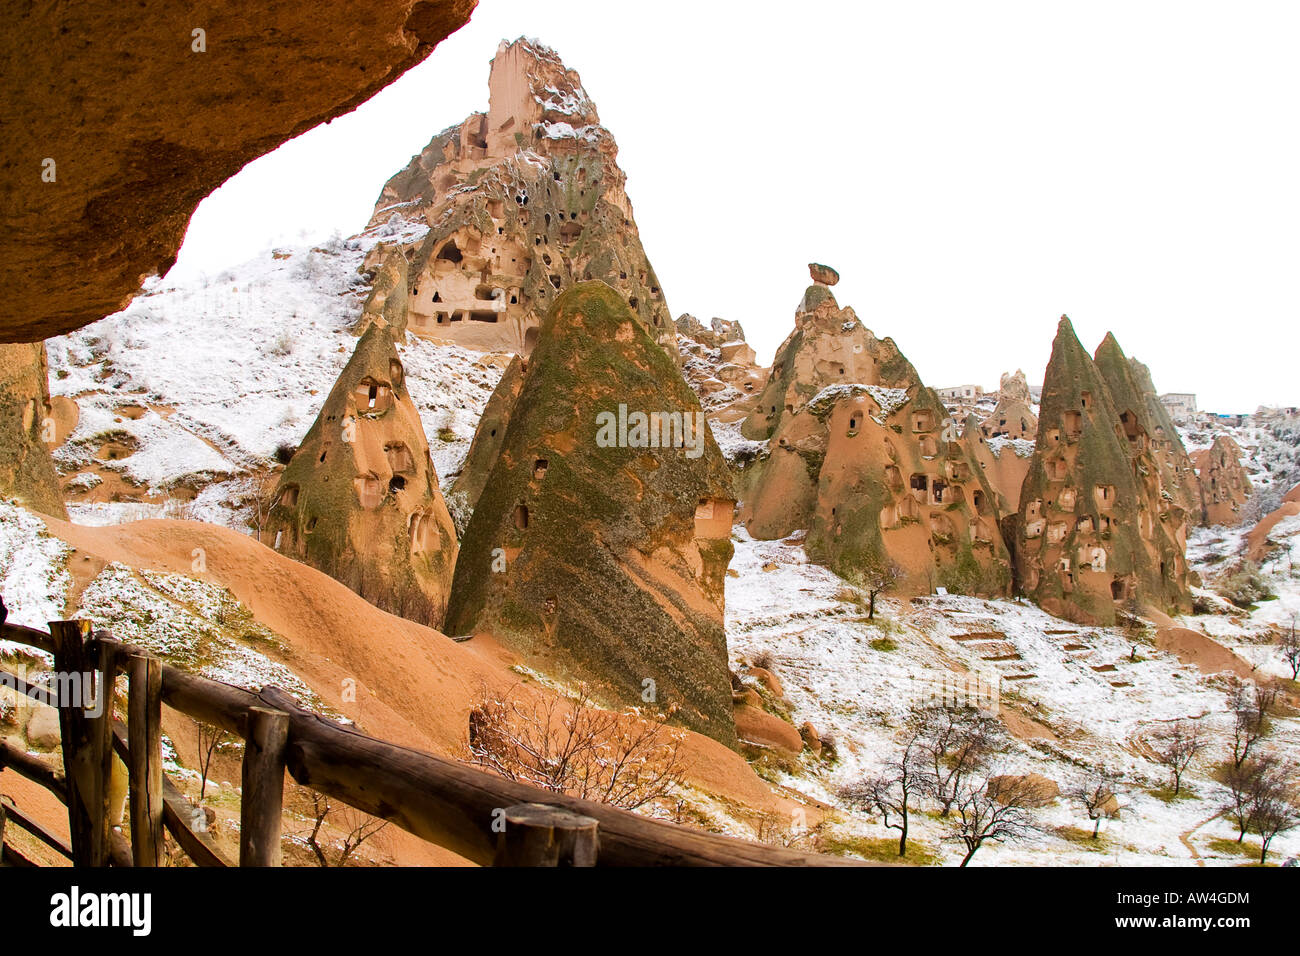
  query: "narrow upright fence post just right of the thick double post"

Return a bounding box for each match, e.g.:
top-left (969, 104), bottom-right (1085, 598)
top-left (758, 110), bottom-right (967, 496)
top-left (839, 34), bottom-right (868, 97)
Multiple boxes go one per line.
top-left (126, 654), bottom-right (163, 866)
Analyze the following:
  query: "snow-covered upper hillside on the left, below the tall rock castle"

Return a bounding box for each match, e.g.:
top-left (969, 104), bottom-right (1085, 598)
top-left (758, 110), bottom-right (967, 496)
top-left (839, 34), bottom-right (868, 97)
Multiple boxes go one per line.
top-left (48, 226), bottom-right (504, 527)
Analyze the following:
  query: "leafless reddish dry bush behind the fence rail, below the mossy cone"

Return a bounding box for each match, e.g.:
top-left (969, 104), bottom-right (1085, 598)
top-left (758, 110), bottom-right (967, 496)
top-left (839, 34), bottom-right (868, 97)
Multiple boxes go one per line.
top-left (469, 685), bottom-right (685, 810)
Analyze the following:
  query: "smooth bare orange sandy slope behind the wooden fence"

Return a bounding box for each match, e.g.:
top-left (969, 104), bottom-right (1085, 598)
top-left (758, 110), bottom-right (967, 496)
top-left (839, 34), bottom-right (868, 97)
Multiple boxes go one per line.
top-left (17, 519), bottom-right (793, 862)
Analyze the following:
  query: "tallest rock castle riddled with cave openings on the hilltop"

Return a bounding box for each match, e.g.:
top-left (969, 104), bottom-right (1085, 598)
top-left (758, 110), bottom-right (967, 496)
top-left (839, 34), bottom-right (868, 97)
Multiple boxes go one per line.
top-left (368, 39), bottom-right (676, 355)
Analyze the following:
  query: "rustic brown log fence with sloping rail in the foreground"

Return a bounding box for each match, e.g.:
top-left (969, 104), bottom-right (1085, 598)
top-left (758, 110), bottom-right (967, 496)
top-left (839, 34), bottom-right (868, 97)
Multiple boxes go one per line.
top-left (0, 620), bottom-right (848, 866)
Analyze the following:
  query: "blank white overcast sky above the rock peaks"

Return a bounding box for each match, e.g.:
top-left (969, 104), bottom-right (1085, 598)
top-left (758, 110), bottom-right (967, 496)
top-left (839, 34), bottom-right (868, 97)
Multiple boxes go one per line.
top-left (173, 0), bottom-right (1300, 411)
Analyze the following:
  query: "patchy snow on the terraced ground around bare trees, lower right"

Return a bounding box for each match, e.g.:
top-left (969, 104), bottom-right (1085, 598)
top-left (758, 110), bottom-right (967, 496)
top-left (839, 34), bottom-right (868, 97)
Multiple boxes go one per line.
top-left (727, 527), bottom-right (1300, 865)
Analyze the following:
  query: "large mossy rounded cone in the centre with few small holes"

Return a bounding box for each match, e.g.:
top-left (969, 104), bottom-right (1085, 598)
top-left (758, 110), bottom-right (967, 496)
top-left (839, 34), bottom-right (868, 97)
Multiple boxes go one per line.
top-left (447, 282), bottom-right (736, 745)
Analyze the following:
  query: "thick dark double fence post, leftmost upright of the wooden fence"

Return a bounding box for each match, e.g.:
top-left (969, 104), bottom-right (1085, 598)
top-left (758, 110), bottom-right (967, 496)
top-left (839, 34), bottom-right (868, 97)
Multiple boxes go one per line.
top-left (49, 620), bottom-right (116, 866)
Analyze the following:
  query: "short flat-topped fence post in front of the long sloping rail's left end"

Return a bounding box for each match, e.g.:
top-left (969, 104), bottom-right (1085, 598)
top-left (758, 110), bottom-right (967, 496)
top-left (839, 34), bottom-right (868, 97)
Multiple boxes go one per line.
top-left (239, 708), bottom-right (289, 866)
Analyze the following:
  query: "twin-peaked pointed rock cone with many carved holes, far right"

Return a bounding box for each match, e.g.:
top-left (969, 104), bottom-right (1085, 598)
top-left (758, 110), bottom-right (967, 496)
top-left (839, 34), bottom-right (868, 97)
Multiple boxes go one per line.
top-left (1015, 316), bottom-right (1191, 624)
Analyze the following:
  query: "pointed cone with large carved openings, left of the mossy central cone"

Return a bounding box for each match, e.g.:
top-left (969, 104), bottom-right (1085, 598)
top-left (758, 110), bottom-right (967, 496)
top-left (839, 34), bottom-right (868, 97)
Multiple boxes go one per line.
top-left (267, 323), bottom-right (456, 627)
